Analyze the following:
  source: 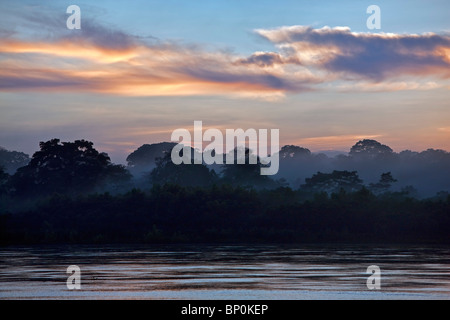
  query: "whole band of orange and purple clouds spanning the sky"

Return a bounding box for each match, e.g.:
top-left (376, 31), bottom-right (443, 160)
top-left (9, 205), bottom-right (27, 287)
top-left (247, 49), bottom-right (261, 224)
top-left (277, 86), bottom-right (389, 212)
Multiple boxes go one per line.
top-left (0, 17), bottom-right (450, 100)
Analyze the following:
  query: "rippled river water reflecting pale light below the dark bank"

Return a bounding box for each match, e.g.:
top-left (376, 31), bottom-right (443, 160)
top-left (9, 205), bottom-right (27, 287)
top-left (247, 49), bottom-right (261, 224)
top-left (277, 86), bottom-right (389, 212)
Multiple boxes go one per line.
top-left (0, 245), bottom-right (450, 300)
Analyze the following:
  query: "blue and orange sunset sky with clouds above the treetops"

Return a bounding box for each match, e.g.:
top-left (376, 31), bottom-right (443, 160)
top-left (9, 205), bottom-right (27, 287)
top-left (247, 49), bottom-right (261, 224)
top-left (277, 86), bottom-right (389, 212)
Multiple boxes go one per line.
top-left (0, 0), bottom-right (450, 163)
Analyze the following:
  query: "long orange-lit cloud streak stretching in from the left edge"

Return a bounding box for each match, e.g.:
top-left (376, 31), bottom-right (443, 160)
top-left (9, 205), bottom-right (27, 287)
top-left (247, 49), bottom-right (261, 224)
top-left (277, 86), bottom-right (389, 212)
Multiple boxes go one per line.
top-left (0, 28), bottom-right (314, 99)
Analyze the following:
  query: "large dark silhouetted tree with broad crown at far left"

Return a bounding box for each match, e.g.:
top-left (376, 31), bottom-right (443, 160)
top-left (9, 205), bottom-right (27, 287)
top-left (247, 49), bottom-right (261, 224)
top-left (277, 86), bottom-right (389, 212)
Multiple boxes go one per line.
top-left (11, 139), bottom-right (131, 195)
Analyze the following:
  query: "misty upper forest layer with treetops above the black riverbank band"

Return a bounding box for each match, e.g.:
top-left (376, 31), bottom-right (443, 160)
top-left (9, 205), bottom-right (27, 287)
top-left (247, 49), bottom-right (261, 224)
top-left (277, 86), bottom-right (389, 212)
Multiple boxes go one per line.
top-left (0, 139), bottom-right (450, 198)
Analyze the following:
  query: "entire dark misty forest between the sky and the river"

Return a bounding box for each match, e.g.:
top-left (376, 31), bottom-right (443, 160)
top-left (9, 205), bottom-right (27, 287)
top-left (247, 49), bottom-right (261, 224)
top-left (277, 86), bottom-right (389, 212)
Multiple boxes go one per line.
top-left (0, 139), bottom-right (450, 244)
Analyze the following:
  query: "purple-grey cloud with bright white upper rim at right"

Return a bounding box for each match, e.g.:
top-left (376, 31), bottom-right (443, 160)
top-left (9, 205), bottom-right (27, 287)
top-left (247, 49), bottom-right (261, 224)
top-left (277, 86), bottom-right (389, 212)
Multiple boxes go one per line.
top-left (256, 26), bottom-right (450, 81)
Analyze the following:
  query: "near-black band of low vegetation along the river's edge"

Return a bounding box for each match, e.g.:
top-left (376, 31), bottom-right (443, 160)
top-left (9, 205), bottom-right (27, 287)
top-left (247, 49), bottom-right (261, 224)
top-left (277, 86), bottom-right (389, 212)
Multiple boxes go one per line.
top-left (0, 186), bottom-right (450, 245)
